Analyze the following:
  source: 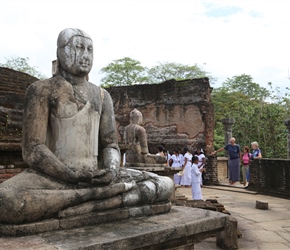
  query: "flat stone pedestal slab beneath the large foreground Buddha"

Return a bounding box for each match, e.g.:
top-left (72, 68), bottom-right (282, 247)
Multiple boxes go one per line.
top-left (0, 206), bottom-right (229, 250)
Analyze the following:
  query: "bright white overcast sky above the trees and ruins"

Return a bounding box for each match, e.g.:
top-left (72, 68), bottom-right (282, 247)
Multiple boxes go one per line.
top-left (0, 0), bottom-right (290, 90)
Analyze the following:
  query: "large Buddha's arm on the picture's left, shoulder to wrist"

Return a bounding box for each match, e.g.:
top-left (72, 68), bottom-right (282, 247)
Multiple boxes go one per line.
top-left (22, 81), bottom-right (90, 182)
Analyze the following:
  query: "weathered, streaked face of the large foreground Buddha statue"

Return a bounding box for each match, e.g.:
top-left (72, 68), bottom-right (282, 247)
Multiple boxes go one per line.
top-left (57, 36), bottom-right (94, 76)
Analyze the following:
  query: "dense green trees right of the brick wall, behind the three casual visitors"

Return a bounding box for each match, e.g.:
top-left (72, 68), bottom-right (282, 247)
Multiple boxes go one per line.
top-left (212, 75), bottom-right (290, 158)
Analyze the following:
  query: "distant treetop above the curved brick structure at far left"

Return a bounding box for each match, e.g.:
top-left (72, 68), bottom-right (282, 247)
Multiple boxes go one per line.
top-left (0, 57), bottom-right (46, 79)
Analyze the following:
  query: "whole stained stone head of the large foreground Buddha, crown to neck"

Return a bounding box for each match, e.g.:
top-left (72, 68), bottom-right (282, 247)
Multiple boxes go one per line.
top-left (53, 28), bottom-right (94, 77)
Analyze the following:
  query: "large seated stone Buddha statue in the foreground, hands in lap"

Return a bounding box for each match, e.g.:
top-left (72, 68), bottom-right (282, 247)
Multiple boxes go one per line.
top-left (0, 28), bottom-right (174, 225)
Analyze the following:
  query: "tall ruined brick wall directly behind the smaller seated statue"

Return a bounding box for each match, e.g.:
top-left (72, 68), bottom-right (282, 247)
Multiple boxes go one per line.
top-left (108, 78), bottom-right (214, 156)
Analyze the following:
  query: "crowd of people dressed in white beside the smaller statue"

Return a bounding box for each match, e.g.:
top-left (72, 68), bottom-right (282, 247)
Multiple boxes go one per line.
top-left (157, 146), bottom-right (205, 200)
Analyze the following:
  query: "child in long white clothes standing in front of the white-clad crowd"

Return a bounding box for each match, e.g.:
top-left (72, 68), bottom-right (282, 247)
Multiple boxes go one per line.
top-left (191, 156), bottom-right (204, 200)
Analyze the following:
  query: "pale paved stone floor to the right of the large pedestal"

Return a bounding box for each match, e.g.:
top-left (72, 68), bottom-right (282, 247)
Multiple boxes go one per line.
top-left (178, 185), bottom-right (290, 250)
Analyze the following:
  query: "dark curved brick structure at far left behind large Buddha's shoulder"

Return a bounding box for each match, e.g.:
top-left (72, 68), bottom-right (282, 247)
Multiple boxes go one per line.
top-left (0, 67), bottom-right (37, 182)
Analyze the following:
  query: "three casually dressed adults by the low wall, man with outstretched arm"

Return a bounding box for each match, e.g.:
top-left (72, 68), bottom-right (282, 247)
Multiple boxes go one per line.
top-left (212, 138), bottom-right (262, 187)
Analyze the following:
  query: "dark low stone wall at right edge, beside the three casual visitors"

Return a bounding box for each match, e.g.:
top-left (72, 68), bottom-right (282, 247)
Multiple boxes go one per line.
top-left (248, 158), bottom-right (290, 198)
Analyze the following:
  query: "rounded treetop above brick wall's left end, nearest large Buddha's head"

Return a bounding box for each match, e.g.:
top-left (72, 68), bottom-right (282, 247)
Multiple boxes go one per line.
top-left (101, 57), bottom-right (147, 87)
